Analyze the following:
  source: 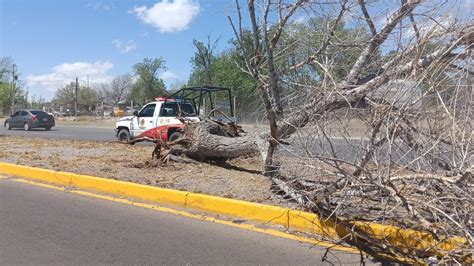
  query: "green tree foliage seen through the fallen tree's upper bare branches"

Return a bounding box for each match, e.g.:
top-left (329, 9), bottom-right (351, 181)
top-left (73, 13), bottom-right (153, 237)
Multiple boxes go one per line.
top-left (275, 17), bottom-right (381, 88)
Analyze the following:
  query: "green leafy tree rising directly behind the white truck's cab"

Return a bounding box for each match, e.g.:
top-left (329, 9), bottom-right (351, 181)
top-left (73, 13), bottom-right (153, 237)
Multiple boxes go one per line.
top-left (130, 57), bottom-right (166, 104)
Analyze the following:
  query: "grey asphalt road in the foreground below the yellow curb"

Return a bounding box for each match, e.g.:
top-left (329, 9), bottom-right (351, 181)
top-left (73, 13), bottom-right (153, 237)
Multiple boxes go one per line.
top-left (0, 179), bottom-right (366, 265)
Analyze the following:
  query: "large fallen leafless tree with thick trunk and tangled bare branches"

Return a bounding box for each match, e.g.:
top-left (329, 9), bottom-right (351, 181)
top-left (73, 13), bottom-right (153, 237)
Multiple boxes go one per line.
top-left (135, 0), bottom-right (474, 263)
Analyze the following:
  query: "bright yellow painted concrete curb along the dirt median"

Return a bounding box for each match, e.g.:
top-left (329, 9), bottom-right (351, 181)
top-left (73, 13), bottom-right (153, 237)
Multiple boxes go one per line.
top-left (0, 163), bottom-right (466, 262)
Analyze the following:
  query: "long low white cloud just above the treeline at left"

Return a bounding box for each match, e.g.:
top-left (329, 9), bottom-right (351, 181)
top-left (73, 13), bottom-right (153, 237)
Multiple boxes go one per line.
top-left (26, 61), bottom-right (114, 92)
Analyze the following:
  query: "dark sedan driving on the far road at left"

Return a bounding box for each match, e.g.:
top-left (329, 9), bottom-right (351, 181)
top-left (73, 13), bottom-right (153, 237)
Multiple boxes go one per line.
top-left (5, 110), bottom-right (55, 131)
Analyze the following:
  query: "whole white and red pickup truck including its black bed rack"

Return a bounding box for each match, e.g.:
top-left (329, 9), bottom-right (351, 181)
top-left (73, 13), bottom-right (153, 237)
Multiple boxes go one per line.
top-left (115, 86), bottom-right (236, 143)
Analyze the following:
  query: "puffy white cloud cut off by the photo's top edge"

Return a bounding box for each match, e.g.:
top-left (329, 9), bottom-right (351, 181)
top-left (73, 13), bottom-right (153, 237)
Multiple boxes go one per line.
top-left (132, 0), bottom-right (199, 33)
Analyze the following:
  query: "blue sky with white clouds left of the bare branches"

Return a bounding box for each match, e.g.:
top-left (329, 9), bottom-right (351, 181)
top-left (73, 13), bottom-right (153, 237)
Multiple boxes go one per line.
top-left (0, 0), bottom-right (237, 99)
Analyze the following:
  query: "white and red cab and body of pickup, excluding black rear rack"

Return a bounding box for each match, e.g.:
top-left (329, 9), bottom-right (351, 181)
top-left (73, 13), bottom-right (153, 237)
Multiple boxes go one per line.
top-left (115, 98), bottom-right (199, 142)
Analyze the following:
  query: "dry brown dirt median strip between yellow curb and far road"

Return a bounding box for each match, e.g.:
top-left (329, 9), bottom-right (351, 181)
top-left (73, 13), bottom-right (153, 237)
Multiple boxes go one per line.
top-left (0, 136), bottom-right (288, 206)
